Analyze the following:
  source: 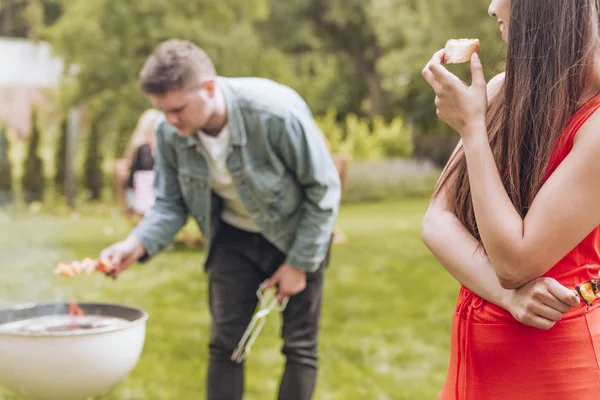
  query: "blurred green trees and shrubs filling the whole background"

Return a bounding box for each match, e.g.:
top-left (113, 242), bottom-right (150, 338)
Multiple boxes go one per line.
top-left (0, 0), bottom-right (504, 209)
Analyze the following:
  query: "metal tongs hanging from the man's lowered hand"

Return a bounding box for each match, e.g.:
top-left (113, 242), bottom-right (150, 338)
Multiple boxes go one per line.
top-left (231, 288), bottom-right (289, 363)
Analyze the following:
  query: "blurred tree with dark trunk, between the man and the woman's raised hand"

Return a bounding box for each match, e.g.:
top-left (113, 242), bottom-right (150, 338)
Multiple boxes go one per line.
top-left (261, 0), bottom-right (394, 115)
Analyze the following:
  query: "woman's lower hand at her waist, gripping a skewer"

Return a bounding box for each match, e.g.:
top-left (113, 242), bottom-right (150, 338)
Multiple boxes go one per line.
top-left (507, 278), bottom-right (579, 330)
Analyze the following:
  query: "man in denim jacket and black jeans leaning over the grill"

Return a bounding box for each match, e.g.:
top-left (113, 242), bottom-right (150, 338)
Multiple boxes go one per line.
top-left (101, 40), bottom-right (340, 400)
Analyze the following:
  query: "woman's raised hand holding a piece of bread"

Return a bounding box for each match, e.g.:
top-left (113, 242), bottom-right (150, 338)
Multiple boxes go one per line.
top-left (422, 50), bottom-right (487, 140)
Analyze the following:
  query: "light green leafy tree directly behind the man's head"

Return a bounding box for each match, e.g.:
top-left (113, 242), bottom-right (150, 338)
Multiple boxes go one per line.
top-left (47, 0), bottom-right (284, 141)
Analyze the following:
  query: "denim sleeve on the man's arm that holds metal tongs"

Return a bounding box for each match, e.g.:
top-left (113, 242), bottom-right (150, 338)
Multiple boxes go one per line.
top-left (274, 114), bottom-right (341, 272)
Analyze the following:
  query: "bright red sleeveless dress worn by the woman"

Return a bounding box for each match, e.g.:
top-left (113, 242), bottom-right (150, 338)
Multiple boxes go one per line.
top-left (439, 96), bottom-right (600, 400)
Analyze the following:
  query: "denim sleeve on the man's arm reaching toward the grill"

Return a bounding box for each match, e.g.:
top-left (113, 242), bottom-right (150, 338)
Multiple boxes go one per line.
top-left (131, 123), bottom-right (188, 261)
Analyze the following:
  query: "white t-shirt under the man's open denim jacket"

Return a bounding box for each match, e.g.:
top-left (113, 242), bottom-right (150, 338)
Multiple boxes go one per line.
top-left (198, 125), bottom-right (260, 232)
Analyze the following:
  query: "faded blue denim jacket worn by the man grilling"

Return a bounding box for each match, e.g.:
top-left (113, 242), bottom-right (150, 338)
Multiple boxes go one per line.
top-left (132, 78), bottom-right (341, 272)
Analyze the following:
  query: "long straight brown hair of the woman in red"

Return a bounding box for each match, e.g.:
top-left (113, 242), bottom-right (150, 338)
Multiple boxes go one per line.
top-left (435, 0), bottom-right (600, 240)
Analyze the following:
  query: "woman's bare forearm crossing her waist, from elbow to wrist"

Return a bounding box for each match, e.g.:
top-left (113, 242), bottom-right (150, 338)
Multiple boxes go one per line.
top-left (422, 209), bottom-right (513, 309)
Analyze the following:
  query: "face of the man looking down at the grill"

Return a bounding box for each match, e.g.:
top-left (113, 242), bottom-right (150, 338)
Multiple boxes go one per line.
top-left (149, 80), bottom-right (215, 137)
